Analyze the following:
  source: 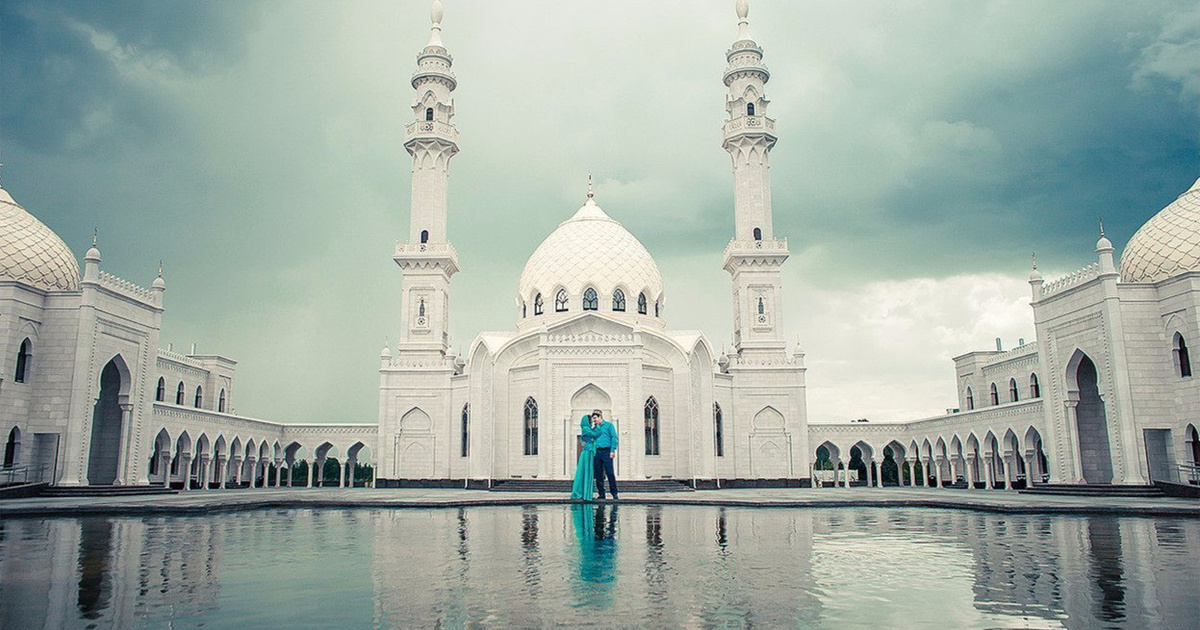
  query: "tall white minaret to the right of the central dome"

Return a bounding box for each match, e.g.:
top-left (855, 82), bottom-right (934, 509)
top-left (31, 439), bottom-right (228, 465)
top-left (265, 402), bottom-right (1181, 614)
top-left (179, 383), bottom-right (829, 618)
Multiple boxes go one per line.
top-left (724, 0), bottom-right (787, 362)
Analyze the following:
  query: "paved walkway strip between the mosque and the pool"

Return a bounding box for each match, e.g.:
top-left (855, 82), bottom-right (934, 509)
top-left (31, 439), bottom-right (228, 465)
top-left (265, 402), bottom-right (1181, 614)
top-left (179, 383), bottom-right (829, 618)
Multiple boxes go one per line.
top-left (0, 488), bottom-right (1200, 517)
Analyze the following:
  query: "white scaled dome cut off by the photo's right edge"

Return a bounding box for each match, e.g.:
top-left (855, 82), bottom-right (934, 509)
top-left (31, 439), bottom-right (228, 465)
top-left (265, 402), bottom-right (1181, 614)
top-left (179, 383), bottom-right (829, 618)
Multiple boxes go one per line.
top-left (1121, 179), bottom-right (1200, 282)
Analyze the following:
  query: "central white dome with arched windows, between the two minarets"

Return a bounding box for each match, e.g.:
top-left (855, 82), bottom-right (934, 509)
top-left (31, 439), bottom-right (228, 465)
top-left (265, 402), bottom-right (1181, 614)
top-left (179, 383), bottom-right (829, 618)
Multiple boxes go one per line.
top-left (517, 194), bottom-right (662, 316)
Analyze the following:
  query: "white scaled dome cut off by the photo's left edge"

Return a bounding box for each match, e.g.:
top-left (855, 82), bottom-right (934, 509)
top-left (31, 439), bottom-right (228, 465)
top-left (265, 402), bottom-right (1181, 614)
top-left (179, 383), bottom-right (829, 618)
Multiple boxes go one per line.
top-left (0, 188), bottom-right (79, 290)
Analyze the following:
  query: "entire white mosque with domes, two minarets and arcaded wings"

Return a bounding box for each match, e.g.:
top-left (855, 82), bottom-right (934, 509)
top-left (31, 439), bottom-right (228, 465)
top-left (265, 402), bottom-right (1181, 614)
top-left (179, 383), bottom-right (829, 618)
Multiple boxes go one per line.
top-left (0, 0), bottom-right (1200, 490)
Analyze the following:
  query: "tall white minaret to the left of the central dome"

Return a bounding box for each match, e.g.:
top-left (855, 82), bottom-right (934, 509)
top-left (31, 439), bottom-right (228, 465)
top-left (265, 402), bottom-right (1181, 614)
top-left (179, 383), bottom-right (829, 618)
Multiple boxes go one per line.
top-left (395, 0), bottom-right (458, 355)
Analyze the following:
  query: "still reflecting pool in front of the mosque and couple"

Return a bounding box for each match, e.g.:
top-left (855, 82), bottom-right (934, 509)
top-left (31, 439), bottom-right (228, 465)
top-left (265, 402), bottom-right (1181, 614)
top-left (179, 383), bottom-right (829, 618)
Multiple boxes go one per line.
top-left (0, 505), bottom-right (1200, 629)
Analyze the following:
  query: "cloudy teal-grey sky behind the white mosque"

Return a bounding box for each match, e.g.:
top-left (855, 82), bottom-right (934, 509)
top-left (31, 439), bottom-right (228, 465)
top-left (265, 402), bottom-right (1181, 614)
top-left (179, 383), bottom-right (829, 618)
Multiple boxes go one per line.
top-left (0, 0), bottom-right (1200, 421)
